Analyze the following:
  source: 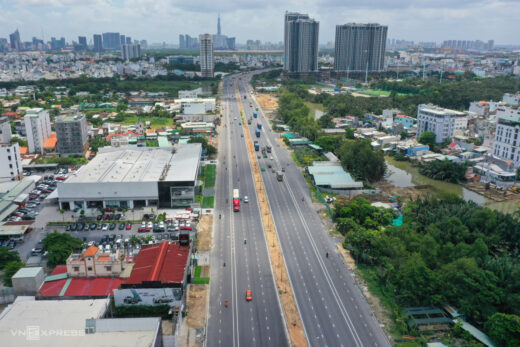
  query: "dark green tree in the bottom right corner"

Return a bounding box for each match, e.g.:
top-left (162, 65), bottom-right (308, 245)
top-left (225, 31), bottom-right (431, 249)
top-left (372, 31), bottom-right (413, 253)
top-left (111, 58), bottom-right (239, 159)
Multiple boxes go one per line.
top-left (486, 312), bottom-right (520, 347)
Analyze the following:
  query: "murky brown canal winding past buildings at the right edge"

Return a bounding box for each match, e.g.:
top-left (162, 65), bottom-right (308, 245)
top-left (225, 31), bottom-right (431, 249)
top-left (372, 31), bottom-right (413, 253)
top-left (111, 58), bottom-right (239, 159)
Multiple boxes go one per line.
top-left (385, 157), bottom-right (520, 213)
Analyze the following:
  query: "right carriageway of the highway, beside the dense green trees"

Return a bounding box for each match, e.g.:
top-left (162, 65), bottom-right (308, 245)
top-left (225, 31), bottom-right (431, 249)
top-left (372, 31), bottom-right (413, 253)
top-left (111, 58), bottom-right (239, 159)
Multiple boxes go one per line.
top-left (239, 73), bottom-right (390, 347)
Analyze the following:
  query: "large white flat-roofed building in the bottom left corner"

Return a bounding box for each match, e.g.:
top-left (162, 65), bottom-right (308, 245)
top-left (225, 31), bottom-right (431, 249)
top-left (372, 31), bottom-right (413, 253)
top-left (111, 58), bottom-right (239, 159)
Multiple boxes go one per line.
top-left (0, 296), bottom-right (162, 347)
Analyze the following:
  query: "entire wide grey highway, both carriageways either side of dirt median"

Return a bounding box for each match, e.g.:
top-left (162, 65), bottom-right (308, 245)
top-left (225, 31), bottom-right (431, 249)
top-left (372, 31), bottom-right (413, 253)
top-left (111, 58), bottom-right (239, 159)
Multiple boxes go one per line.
top-left (207, 73), bottom-right (390, 347)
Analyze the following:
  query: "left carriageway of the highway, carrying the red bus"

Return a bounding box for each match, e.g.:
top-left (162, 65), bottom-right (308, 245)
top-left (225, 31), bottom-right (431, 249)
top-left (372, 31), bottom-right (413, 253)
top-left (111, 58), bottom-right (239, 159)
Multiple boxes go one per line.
top-left (205, 77), bottom-right (288, 347)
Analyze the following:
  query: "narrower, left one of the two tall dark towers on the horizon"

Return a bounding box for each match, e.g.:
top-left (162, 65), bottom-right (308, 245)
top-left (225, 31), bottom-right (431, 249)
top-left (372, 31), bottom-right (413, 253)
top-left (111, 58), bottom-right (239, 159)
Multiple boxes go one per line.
top-left (284, 12), bottom-right (320, 74)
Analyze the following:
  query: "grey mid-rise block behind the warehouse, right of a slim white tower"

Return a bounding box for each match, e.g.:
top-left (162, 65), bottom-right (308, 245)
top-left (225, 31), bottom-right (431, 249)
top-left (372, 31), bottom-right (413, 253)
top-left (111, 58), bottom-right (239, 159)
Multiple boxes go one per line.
top-left (54, 113), bottom-right (88, 156)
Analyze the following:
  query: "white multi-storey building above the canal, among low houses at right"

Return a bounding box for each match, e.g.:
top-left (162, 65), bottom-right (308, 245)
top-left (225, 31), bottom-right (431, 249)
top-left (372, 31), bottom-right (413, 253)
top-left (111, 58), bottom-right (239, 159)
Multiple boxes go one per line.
top-left (417, 104), bottom-right (468, 143)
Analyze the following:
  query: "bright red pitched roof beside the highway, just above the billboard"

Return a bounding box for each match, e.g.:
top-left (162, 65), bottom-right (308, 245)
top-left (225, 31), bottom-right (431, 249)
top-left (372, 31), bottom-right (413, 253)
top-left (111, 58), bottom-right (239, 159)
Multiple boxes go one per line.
top-left (126, 241), bottom-right (190, 284)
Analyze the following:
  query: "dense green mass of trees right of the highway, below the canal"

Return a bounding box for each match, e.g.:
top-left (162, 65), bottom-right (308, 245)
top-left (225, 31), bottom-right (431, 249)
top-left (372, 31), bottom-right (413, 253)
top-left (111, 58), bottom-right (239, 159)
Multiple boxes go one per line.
top-left (334, 195), bottom-right (520, 346)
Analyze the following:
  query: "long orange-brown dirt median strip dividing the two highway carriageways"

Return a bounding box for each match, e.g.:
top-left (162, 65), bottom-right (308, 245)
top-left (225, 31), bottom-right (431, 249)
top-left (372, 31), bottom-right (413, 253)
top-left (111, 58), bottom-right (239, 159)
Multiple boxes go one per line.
top-left (235, 84), bottom-right (307, 347)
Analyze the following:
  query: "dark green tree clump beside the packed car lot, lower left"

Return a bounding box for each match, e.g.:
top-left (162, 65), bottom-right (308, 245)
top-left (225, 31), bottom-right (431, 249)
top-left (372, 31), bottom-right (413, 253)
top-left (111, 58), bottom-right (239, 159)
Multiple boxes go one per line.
top-left (42, 232), bottom-right (83, 267)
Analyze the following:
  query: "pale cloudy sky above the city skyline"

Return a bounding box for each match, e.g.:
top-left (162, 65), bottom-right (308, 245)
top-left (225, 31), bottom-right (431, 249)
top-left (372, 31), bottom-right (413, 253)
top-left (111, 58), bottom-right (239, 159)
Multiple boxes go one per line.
top-left (0, 0), bottom-right (520, 44)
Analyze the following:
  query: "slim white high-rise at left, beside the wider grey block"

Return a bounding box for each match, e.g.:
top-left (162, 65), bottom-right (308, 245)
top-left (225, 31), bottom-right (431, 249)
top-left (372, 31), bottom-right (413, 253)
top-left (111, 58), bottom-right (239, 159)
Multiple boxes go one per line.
top-left (24, 108), bottom-right (51, 153)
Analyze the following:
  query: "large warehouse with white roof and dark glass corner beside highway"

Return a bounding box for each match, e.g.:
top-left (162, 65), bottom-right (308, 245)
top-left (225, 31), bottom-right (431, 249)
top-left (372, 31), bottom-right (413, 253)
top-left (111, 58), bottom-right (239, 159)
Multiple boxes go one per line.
top-left (57, 143), bottom-right (202, 210)
